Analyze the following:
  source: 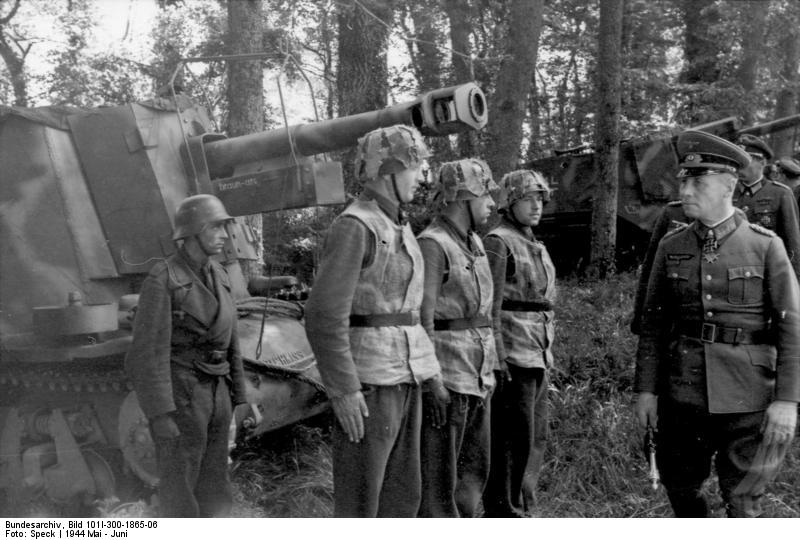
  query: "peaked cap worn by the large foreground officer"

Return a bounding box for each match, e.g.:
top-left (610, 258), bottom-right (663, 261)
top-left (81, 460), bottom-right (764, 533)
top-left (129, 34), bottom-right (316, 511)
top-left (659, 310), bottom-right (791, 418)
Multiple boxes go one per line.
top-left (677, 130), bottom-right (750, 174)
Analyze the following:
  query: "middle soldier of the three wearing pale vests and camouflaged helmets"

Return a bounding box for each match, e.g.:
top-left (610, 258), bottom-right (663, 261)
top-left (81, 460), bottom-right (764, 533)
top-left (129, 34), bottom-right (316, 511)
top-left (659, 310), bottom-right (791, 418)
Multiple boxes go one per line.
top-left (417, 158), bottom-right (498, 517)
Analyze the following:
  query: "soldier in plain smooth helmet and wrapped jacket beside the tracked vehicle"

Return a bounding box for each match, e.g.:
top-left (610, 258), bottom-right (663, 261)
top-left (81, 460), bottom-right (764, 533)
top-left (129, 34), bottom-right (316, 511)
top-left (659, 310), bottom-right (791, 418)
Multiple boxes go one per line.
top-left (125, 195), bottom-right (245, 517)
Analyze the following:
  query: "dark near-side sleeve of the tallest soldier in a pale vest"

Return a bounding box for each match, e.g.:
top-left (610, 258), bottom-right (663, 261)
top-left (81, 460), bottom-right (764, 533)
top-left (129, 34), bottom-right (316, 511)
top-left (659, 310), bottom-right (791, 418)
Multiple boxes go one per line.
top-left (305, 217), bottom-right (372, 397)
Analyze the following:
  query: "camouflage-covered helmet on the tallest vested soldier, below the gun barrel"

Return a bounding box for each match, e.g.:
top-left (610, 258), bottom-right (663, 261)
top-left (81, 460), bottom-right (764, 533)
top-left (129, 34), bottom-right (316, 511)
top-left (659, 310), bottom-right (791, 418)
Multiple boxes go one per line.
top-left (355, 125), bottom-right (431, 180)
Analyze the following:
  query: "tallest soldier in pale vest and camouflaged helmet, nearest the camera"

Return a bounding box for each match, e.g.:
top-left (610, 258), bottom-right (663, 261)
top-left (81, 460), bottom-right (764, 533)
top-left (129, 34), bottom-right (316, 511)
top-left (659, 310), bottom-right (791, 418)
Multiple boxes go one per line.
top-left (306, 125), bottom-right (446, 517)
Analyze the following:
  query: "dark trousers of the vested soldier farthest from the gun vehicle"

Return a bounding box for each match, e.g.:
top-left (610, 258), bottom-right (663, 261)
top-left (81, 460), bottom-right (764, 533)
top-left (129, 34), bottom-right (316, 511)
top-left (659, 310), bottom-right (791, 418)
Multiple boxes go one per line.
top-left (483, 364), bottom-right (549, 517)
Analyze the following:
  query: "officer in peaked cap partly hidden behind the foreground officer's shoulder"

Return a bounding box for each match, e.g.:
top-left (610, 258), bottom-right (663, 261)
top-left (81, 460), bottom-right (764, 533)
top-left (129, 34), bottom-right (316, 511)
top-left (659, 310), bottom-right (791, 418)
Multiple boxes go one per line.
top-left (733, 134), bottom-right (800, 277)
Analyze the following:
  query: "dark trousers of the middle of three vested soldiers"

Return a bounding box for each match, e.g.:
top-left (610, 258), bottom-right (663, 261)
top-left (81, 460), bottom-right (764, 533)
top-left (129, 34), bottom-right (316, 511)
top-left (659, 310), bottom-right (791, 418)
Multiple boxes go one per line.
top-left (419, 392), bottom-right (491, 517)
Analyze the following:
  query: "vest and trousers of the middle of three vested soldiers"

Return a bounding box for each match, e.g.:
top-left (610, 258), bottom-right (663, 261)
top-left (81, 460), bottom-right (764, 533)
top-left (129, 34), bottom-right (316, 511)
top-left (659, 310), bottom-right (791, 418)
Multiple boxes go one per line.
top-left (418, 217), bottom-right (498, 517)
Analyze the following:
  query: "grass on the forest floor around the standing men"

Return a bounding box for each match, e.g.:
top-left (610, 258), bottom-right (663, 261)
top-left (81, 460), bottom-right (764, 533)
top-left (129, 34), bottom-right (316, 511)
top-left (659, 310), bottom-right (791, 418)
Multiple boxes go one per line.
top-left (228, 274), bottom-right (800, 517)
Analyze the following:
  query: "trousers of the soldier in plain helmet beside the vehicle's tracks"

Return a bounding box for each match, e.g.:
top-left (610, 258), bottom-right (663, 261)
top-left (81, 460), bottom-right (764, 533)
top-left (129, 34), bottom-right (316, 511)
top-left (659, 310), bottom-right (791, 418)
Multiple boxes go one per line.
top-left (153, 363), bottom-right (233, 517)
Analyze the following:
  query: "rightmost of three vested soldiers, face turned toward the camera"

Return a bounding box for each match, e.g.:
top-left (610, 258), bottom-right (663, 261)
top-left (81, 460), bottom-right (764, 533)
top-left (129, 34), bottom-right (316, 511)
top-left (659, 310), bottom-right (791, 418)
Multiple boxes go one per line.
top-left (483, 169), bottom-right (556, 517)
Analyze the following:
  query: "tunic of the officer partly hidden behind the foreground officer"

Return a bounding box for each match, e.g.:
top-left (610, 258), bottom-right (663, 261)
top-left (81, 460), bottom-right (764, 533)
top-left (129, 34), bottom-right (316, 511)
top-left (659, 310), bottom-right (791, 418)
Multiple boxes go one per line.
top-left (733, 178), bottom-right (800, 276)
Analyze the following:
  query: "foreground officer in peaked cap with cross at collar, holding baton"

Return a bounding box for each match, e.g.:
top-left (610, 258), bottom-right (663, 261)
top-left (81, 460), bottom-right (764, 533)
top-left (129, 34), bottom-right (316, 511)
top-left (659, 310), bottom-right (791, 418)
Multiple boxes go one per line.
top-left (635, 131), bottom-right (800, 517)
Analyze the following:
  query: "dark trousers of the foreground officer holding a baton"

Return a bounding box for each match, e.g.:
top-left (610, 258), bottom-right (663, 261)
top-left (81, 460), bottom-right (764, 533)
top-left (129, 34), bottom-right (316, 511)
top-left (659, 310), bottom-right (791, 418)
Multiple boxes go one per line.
top-left (656, 397), bottom-right (780, 517)
